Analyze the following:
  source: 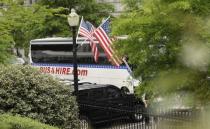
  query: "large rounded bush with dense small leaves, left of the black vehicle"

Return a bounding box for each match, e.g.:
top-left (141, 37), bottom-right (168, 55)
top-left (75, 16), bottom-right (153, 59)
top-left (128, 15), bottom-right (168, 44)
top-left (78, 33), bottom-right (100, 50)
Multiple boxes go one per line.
top-left (0, 65), bottom-right (79, 129)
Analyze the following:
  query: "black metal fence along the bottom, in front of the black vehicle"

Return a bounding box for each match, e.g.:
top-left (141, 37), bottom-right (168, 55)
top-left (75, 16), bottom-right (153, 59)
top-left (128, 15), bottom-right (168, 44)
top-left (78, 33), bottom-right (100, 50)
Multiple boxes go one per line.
top-left (80, 105), bottom-right (199, 129)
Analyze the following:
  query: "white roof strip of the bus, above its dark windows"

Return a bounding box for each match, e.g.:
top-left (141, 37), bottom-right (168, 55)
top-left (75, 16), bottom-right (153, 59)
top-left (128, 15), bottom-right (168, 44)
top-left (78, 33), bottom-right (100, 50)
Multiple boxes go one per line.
top-left (30, 37), bottom-right (98, 44)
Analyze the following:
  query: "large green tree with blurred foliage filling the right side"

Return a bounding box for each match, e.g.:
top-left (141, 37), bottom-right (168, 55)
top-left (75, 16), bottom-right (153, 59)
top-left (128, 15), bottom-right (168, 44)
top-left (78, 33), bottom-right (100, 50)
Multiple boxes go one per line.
top-left (113, 0), bottom-right (210, 105)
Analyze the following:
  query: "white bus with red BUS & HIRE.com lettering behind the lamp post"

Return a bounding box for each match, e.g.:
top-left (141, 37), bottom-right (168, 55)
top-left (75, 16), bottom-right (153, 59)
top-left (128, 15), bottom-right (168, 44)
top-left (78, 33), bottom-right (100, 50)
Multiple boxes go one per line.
top-left (29, 37), bottom-right (139, 93)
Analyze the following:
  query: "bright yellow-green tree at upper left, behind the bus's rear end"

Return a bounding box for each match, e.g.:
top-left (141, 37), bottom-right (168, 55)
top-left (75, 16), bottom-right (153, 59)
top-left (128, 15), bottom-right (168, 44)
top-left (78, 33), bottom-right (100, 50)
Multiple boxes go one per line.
top-left (0, 0), bottom-right (59, 60)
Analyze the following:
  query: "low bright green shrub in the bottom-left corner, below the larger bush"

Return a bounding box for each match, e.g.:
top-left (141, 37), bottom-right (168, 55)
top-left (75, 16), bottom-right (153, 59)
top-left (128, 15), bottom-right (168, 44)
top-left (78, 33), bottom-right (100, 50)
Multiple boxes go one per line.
top-left (0, 114), bottom-right (58, 129)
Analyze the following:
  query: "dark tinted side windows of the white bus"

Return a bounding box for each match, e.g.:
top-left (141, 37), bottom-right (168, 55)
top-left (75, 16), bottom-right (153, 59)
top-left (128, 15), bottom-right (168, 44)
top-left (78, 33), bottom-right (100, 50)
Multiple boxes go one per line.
top-left (31, 44), bottom-right (110, 65)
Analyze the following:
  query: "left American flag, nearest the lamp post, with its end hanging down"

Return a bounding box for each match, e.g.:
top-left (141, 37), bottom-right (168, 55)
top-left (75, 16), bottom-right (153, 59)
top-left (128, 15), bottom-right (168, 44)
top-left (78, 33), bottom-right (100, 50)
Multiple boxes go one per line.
top-left (78, 17), bottom-right (99, 62)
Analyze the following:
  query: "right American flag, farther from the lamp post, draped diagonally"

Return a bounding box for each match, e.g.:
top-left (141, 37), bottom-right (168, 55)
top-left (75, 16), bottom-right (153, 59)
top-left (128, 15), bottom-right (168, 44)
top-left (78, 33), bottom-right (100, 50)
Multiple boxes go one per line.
top-left (94, 18), bottom-right (122, 66)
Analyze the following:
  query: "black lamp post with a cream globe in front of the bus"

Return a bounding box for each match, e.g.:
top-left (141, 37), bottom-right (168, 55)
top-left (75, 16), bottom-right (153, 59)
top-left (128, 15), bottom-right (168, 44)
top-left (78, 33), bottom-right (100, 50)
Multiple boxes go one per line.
top-left (68, 9), bottom-right (79, 96)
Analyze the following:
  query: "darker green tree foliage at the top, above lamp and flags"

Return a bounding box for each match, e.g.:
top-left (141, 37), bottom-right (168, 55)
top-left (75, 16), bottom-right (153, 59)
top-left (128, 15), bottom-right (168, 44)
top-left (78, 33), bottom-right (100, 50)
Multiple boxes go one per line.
top-left (38, 0), bottom-right (114, 24)
